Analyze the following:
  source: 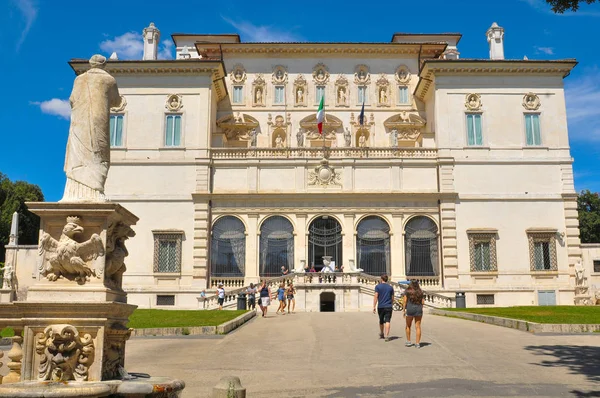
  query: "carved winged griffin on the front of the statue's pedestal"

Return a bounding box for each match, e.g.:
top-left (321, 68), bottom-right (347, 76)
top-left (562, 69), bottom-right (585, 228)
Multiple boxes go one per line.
top-left (39, 217), bottom-right (104, 282)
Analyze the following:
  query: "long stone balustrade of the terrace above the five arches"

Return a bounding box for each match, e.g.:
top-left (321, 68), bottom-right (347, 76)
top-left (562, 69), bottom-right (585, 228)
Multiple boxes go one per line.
top-left (211, 148), bottom-right (437, 159)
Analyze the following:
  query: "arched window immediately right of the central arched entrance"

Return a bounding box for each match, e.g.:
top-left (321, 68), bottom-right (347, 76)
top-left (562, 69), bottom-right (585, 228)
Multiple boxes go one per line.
top-left (356, 216), bottom-right (390, 276)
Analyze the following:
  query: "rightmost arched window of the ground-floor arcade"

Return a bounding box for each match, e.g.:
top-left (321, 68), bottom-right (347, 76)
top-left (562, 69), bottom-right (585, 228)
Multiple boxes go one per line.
top-left (405, 216), bottom-right (438, 276)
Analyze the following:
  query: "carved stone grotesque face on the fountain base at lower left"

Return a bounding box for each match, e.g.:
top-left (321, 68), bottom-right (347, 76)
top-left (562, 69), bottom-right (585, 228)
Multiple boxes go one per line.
top-left (35, 324), bottom-right (94, 382)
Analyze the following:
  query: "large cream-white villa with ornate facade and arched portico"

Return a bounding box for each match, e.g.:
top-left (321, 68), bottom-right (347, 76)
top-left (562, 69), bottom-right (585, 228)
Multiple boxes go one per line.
top-left (63, 24), bottom-right (581, 310)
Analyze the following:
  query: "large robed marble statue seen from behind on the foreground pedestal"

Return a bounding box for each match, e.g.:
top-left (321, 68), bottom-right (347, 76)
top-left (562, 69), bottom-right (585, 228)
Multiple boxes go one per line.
top-left (61, 55), bottom-right (121, 202)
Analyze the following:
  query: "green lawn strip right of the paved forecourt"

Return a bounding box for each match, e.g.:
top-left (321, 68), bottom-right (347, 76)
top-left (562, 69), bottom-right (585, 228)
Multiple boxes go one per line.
top-left (448, 305), bottom-right (600, 324)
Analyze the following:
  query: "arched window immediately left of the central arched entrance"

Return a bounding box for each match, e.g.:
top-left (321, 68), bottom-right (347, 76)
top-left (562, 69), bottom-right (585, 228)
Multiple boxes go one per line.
top-left (260, 216), bottom-right (294, 276)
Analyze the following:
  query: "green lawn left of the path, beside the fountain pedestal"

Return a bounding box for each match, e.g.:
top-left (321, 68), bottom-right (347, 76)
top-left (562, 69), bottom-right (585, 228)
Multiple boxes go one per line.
top-left (128, 309), bottom-right (246, 329)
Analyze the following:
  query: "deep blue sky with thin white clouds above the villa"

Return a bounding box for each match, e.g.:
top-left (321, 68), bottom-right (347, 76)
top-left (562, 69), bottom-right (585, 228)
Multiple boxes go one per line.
top-left (0, 0), bottom-right (600, 201)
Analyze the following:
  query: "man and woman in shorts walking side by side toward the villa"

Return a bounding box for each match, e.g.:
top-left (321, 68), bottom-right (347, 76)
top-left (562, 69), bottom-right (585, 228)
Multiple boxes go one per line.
top-left (373, 275), bottom-right (425, 348)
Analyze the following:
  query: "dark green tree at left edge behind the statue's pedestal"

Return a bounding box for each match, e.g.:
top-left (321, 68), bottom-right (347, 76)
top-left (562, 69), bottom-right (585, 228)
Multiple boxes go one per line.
top-left (0, 173), bottom-right (44, 262)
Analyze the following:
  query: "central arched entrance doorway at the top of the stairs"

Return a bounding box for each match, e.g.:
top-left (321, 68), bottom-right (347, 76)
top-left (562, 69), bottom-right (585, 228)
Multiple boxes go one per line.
top-left (308, 216), bottom-right (342, 271)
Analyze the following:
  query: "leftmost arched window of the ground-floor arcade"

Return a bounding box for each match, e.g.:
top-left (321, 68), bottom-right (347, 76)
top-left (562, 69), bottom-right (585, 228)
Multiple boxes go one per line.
top-left (210, 216), bottom-right (246, 276)
